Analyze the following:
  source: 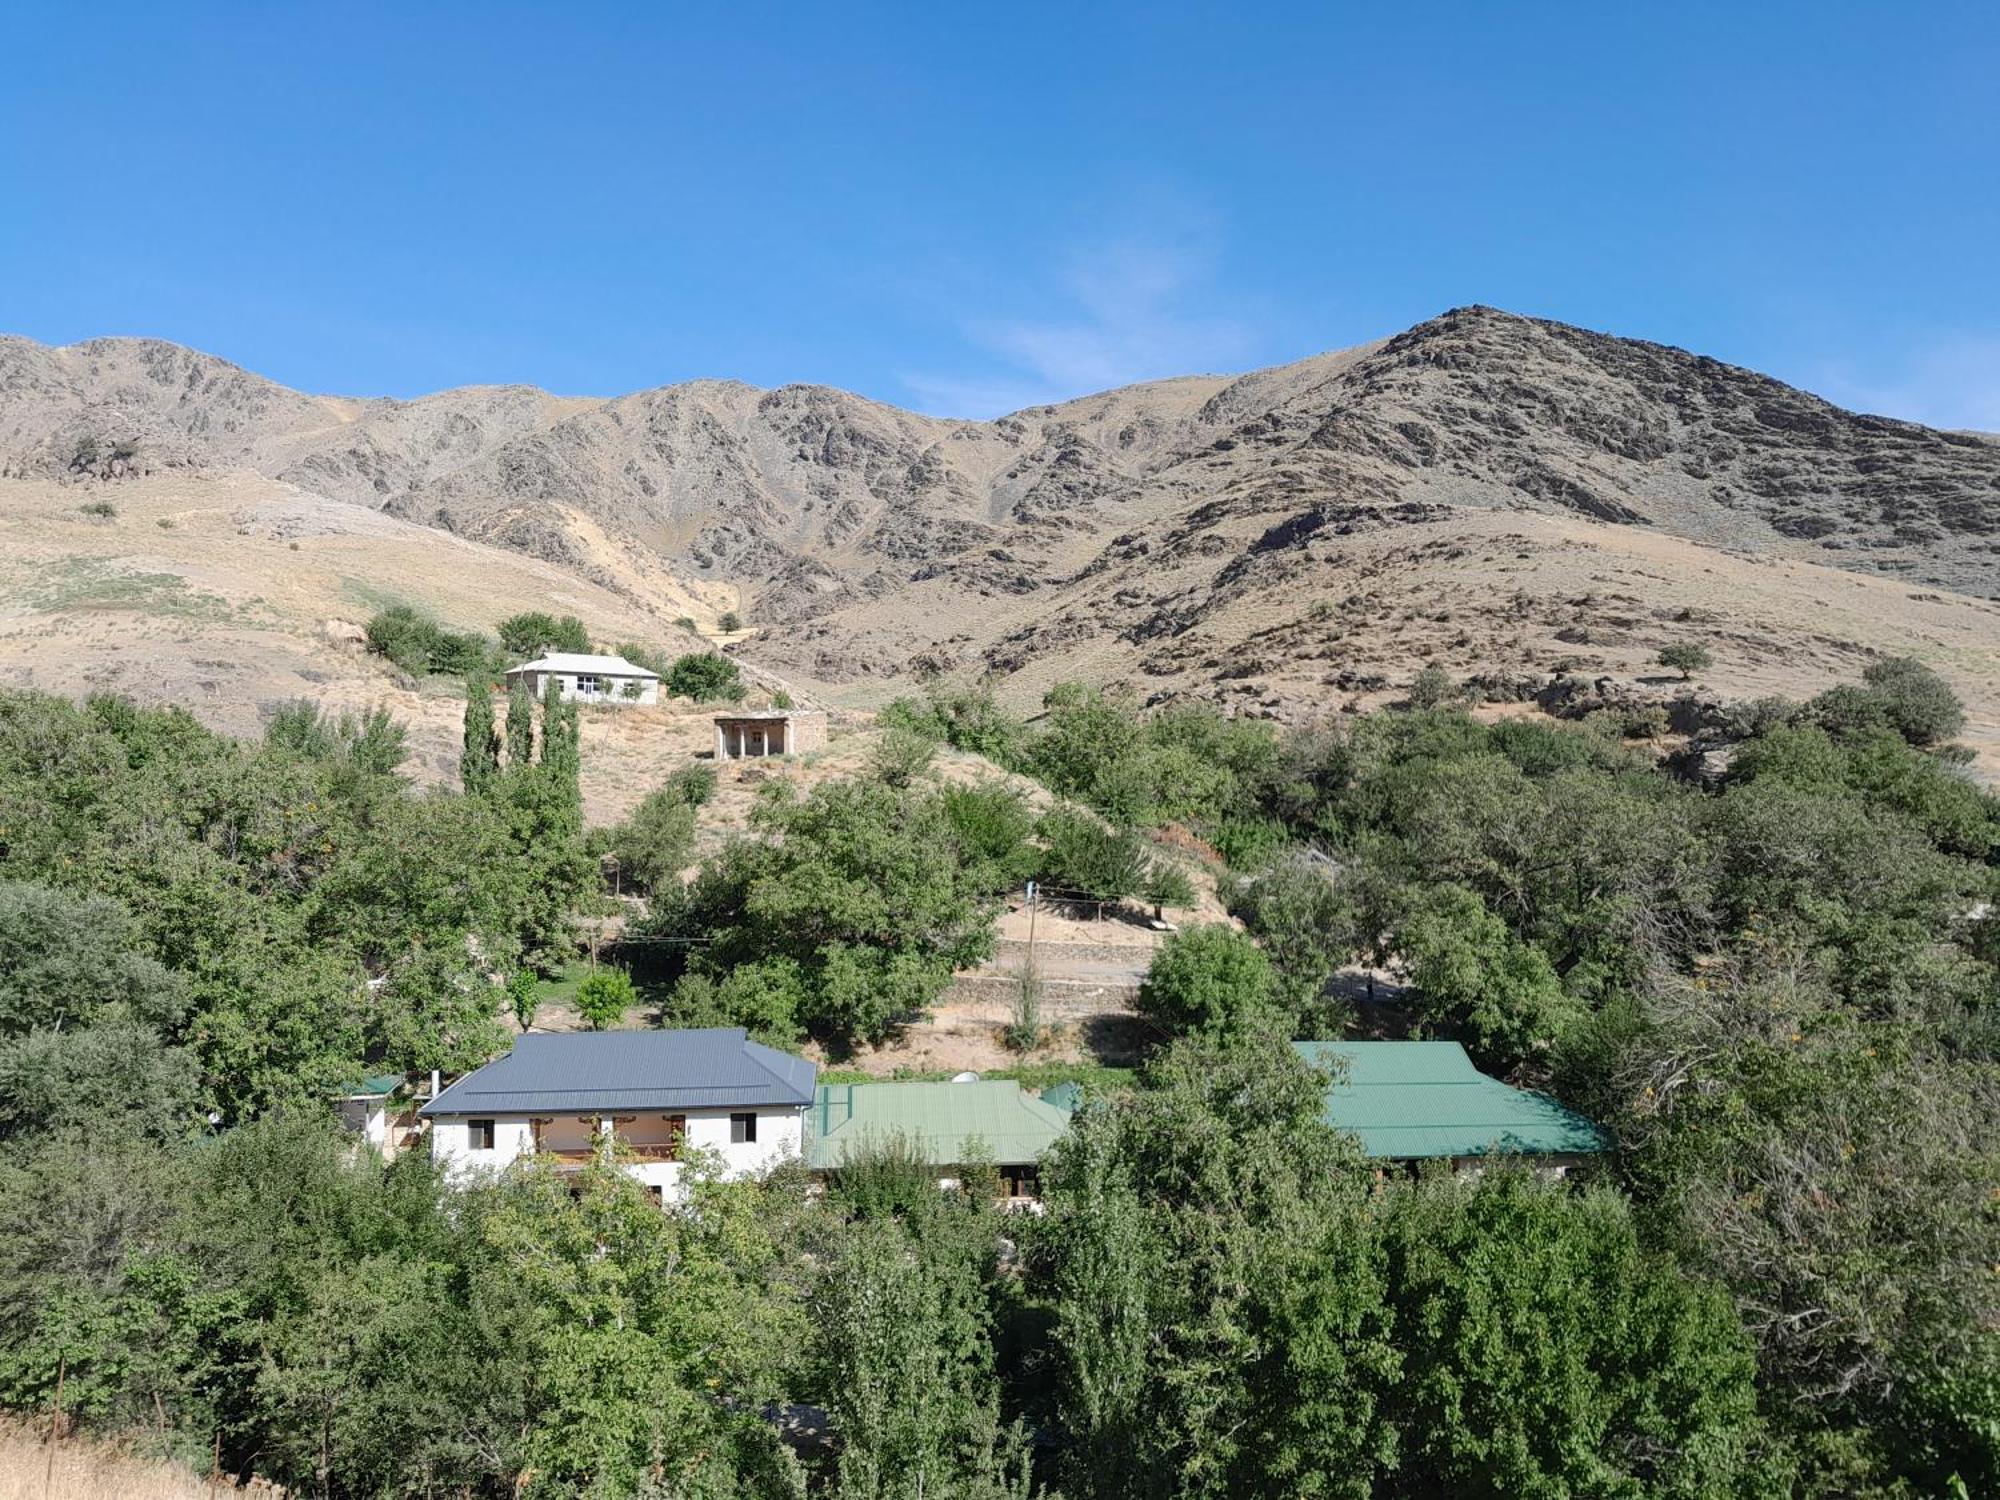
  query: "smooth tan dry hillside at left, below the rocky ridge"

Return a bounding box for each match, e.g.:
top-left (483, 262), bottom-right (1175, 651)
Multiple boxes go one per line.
top-left (0, 472), bottom-right (716, 812)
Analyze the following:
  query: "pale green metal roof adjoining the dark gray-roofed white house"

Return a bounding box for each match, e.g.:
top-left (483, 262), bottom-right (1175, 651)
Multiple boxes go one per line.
top-left (806, 1078), bottom-right (1070, 1168)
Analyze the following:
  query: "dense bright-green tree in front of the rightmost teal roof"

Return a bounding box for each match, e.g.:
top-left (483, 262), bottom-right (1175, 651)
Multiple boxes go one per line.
top-left (1382, 1172), bottom-right (1780, 1500)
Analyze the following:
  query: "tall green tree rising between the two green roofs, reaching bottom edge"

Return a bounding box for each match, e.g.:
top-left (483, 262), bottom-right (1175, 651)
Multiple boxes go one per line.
top-left (1036, 1040), bottom-right (1390, 1500)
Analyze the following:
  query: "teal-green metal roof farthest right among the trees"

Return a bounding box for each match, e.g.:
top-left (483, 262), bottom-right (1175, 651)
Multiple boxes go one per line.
top-left (1292, 1042), bottom-right (1606, 1160)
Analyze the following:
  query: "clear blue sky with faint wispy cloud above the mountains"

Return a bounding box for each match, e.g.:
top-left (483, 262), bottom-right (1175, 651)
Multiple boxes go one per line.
top-left (0, 0), bottom-right (2000, 428)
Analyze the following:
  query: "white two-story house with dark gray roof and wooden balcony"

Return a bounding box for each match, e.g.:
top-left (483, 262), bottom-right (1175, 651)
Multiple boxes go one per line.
top-left (422, 1026), bottom-right (818, 1202)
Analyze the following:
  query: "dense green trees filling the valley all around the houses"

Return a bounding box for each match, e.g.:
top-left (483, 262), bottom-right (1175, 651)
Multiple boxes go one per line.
top-left (0, 662), bottom-right (2000, 1500)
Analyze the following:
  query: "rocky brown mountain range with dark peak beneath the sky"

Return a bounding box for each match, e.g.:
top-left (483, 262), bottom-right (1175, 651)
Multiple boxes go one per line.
top-left (0, 308), bottom-right (2000, 768)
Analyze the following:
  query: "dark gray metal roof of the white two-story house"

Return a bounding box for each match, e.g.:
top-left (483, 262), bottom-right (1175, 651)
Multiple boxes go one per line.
top-left (422, 1026), bottom-right (818, 1114)
